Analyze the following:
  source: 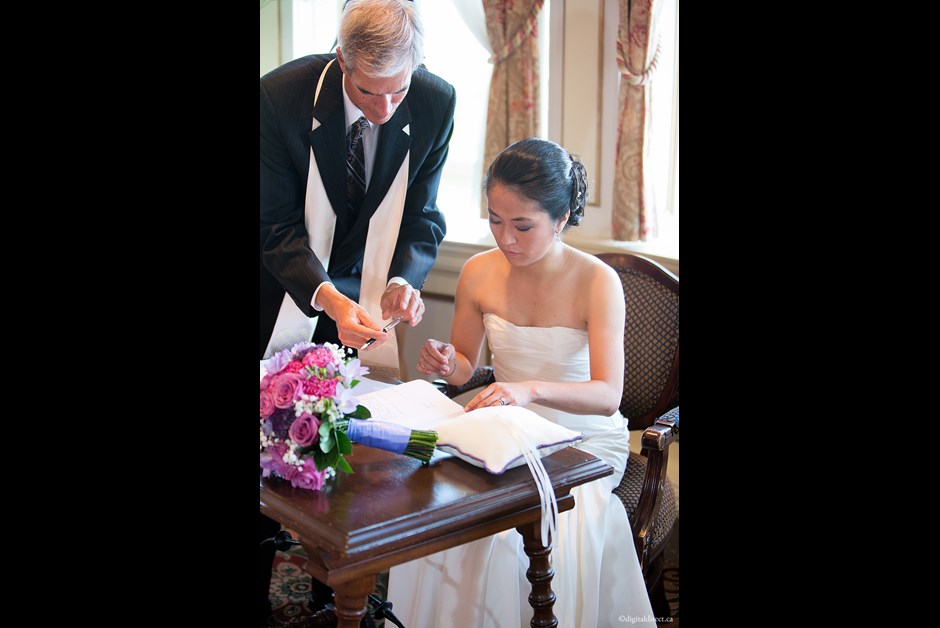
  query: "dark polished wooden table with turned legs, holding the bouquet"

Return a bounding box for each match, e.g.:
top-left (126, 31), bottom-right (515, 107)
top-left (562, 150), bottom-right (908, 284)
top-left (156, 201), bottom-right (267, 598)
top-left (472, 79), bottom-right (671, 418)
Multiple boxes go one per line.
top-left (260, 445), bottom-right (613, 628)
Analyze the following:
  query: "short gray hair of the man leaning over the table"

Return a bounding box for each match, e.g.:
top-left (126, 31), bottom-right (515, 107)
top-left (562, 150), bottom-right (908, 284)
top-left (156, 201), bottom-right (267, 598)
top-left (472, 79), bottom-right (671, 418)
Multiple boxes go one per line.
top-left (337, 0), bottom-right (424, 78)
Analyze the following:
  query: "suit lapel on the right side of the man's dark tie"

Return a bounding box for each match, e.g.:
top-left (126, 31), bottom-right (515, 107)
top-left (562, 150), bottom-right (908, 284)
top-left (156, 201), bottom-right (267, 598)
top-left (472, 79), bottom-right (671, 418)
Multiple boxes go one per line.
top-left (341, 99), bottom-right (411, 247)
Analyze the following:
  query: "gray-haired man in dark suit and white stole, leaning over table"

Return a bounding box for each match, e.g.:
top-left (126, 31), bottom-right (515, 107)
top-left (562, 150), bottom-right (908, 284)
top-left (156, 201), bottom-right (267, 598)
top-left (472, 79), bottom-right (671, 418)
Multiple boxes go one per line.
top-left (260, 0), bottom-right (456, 614)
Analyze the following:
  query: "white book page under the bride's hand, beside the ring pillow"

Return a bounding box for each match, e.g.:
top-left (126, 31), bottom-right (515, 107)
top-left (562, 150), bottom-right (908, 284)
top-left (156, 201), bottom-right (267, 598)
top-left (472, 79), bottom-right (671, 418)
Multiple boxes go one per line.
top-left (353, 379), bottom-right (464, 430)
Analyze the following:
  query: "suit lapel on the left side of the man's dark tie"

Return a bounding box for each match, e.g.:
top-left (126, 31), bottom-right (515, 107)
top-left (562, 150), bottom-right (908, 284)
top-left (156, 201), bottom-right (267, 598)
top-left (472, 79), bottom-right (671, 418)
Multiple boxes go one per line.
top-left (309, 63), bottom-right (346, 236)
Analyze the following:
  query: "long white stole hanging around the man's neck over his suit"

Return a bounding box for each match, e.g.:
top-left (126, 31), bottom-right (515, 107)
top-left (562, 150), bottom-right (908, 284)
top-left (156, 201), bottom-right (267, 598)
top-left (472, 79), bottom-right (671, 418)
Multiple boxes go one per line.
top-left (264, 60), bottom-right (411, 371)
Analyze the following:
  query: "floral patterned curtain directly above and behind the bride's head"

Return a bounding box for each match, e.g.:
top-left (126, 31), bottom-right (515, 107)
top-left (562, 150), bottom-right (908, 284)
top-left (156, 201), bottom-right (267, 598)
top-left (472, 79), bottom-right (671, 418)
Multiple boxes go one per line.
top-left (480, 0), bottom-right (544, 218)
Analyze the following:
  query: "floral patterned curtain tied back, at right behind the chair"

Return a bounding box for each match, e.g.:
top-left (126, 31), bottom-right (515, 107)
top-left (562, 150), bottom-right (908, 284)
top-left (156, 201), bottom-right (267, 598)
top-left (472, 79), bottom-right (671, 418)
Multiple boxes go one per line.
top-left (611, 0), bottom-right (662, 240)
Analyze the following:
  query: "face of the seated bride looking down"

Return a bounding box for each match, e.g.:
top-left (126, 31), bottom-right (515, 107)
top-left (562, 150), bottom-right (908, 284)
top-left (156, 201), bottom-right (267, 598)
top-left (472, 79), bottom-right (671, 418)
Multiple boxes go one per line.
top-left (486, 184), bottom-right (557, 266)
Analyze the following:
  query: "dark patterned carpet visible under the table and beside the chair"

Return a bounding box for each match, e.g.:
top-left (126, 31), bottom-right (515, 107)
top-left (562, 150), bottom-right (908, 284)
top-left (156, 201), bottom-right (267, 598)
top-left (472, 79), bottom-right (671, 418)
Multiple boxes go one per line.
top-left (271, 519), bottom-right (679, 628)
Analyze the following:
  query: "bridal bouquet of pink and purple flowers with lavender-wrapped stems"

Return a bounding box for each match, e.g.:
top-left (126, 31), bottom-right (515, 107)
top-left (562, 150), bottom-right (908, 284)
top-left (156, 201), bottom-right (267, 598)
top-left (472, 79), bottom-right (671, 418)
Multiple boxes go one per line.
top-left (261, 342), bottom-right (437, 491)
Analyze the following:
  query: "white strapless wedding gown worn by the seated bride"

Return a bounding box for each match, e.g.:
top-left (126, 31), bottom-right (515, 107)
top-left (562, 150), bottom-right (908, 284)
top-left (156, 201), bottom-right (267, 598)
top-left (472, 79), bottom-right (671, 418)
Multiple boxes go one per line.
top-left (388, 314), bottom-right (656, 628)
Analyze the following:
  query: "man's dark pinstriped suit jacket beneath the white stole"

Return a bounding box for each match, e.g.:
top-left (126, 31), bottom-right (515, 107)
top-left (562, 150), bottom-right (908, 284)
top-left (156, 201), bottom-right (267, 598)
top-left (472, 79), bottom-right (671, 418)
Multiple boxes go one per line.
top-left (260, 54), bottom-right (456, 353)
